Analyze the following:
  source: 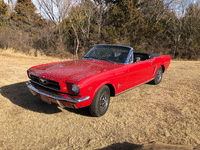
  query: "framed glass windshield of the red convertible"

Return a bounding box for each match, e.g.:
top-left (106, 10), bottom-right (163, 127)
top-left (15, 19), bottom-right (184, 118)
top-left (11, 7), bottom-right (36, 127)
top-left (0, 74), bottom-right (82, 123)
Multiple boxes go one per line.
top-left (83, 45), bottom-right (130, 63)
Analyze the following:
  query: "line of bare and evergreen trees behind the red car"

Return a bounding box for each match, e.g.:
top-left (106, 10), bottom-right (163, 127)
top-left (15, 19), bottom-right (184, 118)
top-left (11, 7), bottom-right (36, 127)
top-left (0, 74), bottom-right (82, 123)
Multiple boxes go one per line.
top-left (0, 0), bottom-right (200, 60)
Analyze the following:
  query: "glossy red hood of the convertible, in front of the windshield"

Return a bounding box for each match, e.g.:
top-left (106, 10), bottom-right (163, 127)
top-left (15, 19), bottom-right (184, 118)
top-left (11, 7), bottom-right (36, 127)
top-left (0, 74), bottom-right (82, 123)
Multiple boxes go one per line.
top-left (30, 59), bottom-right (123, 82)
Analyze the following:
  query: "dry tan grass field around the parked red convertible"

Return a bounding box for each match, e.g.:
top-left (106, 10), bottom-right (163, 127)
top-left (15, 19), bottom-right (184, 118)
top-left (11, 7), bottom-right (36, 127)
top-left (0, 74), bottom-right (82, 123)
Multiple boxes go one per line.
top-left (0, 49), bottom-right (200, 150)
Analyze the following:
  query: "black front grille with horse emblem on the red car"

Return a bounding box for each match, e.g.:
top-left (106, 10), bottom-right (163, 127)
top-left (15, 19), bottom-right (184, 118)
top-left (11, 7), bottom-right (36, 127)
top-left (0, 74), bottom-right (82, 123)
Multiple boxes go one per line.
top-left (30, 75), bottom-right (60, 91)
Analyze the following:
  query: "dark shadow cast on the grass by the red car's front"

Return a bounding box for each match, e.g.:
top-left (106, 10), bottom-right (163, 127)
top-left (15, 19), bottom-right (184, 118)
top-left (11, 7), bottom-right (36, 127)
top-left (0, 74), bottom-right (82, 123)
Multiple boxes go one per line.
top-left (0, 82), bottom-right (90, 116)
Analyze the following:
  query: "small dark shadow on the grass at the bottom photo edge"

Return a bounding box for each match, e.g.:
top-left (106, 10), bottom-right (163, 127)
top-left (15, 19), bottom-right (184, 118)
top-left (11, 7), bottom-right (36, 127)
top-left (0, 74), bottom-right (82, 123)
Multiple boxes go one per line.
top-left (98, 142), bottom-right (142, 150)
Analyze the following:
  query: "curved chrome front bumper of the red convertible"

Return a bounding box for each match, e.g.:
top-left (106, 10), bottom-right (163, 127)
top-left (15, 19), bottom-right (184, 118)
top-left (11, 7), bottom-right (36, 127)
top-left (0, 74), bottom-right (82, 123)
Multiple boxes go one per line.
top-left (26, 81), bottom-right (90, 103)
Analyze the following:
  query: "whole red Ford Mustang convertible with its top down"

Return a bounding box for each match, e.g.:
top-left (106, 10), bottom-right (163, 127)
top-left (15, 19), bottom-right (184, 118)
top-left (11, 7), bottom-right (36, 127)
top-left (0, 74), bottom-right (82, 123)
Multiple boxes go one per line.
top-left (27, 45), bottom-right (171, 117)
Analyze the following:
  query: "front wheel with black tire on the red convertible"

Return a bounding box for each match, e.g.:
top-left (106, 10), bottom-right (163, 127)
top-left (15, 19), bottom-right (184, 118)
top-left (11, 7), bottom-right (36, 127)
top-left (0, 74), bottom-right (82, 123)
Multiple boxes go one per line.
top-left (89, 85), bottom-right (110, 117)
